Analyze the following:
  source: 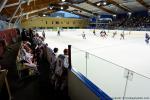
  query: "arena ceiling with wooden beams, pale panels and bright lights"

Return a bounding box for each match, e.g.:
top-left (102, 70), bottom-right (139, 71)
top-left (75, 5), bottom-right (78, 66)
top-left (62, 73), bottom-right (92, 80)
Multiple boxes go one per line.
top-left (0, 0), bottom-right (150, 21)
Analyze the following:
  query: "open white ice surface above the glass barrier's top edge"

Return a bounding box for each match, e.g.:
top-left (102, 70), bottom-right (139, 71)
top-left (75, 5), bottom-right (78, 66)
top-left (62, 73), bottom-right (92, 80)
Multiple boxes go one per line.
top-left (39, 30), bottom-right (150, 77)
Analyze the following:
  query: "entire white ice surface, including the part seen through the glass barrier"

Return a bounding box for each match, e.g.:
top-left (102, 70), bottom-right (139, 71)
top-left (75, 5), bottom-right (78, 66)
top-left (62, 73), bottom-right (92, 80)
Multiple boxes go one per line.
top-left (38, 29), bottom-right (150, 97)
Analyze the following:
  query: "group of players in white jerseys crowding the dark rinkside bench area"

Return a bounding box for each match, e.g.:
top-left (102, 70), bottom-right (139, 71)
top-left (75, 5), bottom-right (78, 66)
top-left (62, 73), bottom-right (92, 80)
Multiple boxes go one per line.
top-left (18, 29), bottom-right (69, 94)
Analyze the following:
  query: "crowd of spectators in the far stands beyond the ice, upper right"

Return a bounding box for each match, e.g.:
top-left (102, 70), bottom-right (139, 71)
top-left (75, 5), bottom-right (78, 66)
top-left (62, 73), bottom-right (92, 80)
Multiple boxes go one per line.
top-left (96, 15), bottom-right (150, 30)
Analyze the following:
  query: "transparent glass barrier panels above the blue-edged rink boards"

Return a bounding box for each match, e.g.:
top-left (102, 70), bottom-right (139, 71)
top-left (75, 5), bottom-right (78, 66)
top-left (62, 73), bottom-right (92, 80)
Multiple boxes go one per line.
top-left (71, 47), bottom-right (150, 100)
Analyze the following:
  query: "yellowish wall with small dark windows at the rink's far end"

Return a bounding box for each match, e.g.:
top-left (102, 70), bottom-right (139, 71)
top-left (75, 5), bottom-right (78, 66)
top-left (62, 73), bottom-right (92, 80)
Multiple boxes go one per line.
top-left (21, 17), bottom-right (89, 29)
